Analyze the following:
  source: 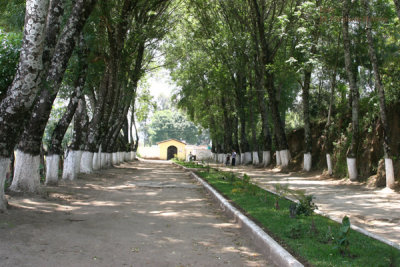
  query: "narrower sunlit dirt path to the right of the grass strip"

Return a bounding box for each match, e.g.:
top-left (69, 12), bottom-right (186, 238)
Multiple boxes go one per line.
top-left (214, 166), bottom-right (400, 248)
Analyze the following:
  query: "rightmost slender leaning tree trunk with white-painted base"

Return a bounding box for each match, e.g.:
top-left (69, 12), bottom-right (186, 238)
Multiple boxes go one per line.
top-left (363, 0), bottom-right (400, 189)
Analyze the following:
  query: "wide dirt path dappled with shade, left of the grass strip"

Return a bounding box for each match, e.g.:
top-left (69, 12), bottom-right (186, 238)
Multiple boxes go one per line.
top-left (0, 162), bottom-right (270, 266)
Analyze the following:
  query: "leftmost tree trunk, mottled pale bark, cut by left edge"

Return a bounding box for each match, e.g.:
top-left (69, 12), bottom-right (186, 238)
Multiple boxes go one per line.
top-left (0, 0), bottom-right (49, 210)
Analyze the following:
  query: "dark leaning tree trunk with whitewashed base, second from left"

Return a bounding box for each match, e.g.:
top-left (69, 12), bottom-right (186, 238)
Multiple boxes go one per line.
top-left (10, 0), bottom-right (96, 192)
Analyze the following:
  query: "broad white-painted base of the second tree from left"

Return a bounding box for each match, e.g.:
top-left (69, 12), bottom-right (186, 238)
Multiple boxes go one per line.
top-left (10, 150), bottom-right (40, 193)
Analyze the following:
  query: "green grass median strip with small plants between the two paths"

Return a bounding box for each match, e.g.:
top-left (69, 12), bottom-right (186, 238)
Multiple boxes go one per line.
top-left (192, 170), bottom-right (400, 267)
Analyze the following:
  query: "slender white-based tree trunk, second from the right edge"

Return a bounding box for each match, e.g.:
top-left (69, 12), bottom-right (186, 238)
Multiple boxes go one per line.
top-left (342, 0), bottom-right (359, 181)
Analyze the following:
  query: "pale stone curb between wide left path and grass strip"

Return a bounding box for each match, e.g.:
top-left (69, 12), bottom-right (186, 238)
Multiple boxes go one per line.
top-left (173, 163), bottom-right (304, 267)
